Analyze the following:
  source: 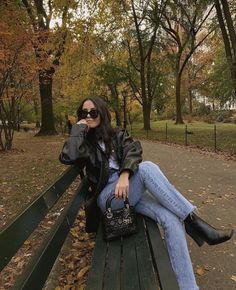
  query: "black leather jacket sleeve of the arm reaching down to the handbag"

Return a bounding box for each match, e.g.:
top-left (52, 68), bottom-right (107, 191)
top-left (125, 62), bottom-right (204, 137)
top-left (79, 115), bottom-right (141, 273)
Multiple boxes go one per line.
top-left (120, 131), bottom-right (143, 175)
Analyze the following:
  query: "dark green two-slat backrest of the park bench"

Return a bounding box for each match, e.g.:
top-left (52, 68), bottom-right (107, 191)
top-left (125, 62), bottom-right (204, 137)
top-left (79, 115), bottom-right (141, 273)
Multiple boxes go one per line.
top-left (0, 166), bottom-right (88, 290)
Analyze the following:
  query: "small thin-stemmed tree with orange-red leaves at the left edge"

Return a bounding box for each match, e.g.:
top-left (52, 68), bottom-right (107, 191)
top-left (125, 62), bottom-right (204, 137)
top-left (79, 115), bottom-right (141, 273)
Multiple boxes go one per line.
top-left (0, 3), bottom-right (35, 150)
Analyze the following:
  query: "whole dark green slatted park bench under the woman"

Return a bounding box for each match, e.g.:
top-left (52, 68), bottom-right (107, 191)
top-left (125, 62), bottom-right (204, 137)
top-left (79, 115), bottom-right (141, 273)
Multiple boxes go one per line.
top-left (0, 166), bottom-right (179, 290)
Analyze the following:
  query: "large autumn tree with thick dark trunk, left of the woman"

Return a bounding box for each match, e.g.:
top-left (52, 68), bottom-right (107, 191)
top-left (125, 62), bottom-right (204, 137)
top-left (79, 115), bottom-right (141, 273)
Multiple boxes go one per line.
top-left (22, 0), bottom-right (75, 135)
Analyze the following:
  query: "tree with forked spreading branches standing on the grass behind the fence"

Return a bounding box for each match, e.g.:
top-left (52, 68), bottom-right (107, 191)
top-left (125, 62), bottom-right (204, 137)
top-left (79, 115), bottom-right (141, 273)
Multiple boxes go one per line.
top-left (161, 0), bottom-right (214, 124)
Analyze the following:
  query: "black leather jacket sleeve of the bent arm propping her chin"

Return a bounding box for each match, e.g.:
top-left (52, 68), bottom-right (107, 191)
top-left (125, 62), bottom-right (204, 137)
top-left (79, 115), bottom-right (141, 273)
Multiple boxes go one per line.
top-left (59, 124), bottom-right (89, 165)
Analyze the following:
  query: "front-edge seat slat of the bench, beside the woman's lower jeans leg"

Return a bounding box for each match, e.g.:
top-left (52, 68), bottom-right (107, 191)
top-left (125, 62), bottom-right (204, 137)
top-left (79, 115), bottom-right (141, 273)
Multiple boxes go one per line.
top-left (145, 217), bottom-right (179, 290)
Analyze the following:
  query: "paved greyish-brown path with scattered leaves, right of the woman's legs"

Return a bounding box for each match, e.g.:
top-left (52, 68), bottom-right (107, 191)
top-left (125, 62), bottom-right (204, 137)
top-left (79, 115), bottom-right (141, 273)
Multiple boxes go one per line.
top-left (141, 141), bottom-right (236, 290)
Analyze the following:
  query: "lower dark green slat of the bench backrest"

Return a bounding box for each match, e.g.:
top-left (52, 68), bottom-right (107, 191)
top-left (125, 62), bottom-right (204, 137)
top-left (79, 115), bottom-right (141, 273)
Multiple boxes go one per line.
top-left (12, 180), bottom-right (88, 290)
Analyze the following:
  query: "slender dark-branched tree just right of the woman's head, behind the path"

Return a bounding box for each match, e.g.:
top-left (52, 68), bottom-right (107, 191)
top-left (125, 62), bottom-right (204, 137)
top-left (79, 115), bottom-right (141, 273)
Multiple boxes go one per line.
top-left (120, 0), bottom-right (166, 130)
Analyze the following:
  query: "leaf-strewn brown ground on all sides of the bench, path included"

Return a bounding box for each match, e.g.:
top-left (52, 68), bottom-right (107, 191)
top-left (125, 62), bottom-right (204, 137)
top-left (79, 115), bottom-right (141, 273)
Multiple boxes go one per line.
top-left (0, 132), bottom-right (236, 290)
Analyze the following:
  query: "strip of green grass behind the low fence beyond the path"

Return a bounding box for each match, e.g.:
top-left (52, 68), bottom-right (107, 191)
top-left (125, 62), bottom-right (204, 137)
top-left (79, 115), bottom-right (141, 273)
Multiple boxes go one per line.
top-left (127, 121), bottom-right (236, 154)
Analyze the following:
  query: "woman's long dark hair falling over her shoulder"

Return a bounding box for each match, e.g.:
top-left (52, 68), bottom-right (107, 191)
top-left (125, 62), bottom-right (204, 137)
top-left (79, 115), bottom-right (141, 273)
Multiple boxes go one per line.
top-left (77, 97), bottom-right (115, 155)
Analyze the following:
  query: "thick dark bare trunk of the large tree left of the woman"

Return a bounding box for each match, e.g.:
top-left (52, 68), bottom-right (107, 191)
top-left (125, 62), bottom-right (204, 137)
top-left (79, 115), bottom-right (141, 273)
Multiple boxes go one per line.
top-left (37, 70), bottom-right (57, 136)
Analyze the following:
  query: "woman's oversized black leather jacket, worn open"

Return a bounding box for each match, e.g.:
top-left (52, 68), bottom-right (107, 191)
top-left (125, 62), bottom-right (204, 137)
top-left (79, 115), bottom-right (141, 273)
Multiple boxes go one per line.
top-left (59, 124), bottom-right (142, 191)
